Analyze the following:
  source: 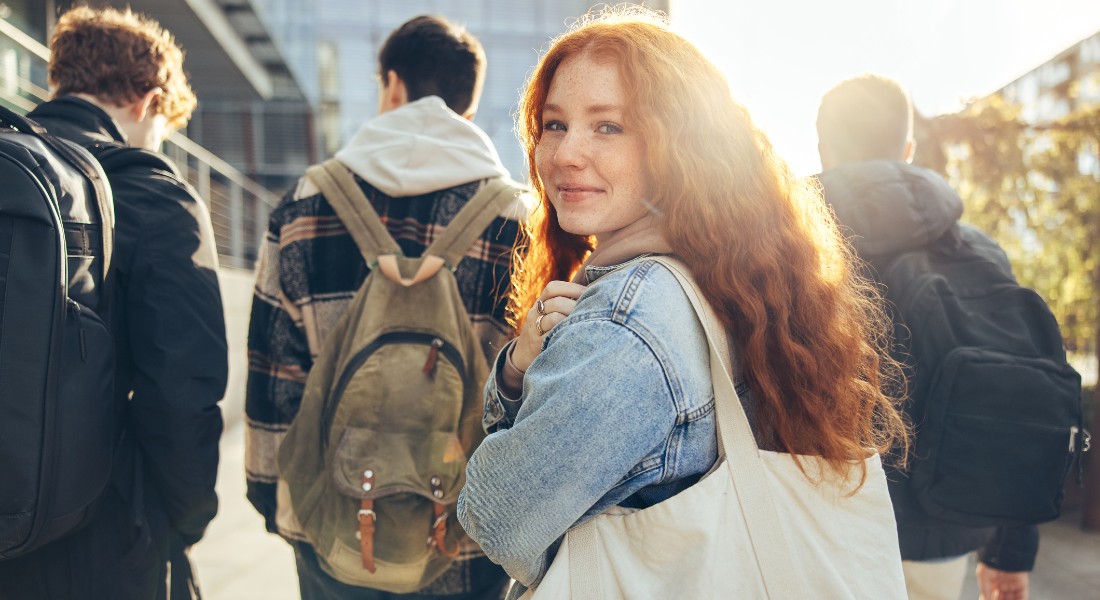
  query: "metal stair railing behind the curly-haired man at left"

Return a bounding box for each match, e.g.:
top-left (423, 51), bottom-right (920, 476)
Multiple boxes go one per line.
top-left (0, 19), bottom-right (278, 269)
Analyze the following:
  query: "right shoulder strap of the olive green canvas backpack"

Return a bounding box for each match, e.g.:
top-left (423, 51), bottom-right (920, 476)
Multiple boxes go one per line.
top-left (425, 177), bottom-right (523, 269)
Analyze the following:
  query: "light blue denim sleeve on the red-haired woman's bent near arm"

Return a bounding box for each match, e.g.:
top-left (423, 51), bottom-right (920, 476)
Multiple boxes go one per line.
top-left (458, 316), bottom-right (677, 586)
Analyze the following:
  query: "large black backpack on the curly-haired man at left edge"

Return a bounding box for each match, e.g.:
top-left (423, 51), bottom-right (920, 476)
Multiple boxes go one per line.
top-left (0, 107), bottom-right (120, 559)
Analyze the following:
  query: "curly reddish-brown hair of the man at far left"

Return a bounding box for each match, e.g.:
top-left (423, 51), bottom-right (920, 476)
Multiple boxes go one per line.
top-left (48, 7), bottom-right (197, 129)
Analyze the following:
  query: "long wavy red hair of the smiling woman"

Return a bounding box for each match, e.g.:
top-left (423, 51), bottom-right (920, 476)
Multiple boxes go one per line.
top-left (510, 8), bottom-right (908, 480)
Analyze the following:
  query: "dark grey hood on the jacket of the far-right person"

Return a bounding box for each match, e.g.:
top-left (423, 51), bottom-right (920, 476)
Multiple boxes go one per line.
top-left (817, 161), bottom-right (963, 258)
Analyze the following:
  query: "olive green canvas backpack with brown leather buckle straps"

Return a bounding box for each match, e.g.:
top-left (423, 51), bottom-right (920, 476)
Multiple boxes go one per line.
top-left (278, 161), bottom-right (520, 593)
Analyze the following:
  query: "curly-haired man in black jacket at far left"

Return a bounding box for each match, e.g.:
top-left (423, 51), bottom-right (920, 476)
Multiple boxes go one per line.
top-left (0, 7), bottom-right (228, 600)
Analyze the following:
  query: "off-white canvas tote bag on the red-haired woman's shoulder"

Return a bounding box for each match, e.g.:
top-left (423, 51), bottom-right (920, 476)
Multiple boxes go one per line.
top-left (523, 258), bottom-right (906, 600)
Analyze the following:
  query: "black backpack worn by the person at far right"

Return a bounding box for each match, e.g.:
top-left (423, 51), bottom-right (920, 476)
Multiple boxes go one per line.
top-left (872, 229), bottom-right (1088, 527)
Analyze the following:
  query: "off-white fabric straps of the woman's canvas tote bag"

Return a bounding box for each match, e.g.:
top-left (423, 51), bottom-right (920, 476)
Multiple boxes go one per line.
top-left (569, 257), bottom-right (811, 600)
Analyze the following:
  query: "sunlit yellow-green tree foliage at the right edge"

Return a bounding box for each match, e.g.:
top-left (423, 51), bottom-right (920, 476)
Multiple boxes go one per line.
top-left (916, 96), bottom-right (1100, 530)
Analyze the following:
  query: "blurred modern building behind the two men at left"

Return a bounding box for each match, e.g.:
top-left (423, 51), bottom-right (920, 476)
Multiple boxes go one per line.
top-left (0, 0), bottom-right (669, 268)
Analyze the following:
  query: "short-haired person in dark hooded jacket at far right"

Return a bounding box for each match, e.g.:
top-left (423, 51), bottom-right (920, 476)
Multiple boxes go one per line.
top-left (817, 75), bottom-right (1038, 600)
